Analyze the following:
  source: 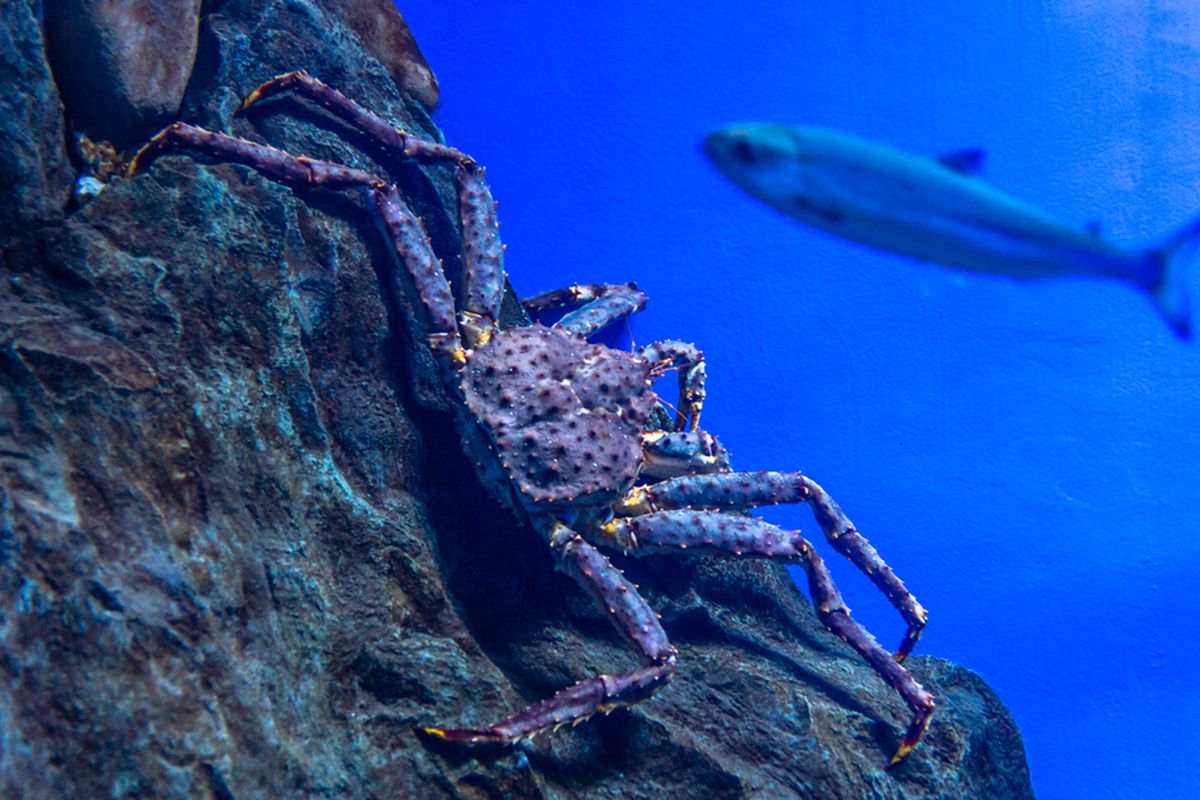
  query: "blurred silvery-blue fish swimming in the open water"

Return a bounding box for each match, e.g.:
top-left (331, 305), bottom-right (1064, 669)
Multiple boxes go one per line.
top-left (703, 124), bottom-right (1200, 339)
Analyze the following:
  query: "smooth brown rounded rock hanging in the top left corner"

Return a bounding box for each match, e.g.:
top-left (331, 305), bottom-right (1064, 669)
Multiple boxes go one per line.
top-left (43, 0), bottom-right (200, 146)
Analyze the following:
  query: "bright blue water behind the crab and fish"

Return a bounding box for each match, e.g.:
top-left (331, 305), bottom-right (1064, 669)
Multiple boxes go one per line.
top-left (401, 0), bottom-right (1200, 800)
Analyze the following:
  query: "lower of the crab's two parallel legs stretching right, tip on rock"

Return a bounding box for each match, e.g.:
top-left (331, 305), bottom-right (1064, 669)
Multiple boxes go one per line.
top-left (600, 510), bottom-right (934, 764)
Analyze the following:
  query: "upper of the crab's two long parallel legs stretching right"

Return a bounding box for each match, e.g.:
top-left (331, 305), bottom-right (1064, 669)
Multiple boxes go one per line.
top-left (620, 470), bottom-right (928, 661)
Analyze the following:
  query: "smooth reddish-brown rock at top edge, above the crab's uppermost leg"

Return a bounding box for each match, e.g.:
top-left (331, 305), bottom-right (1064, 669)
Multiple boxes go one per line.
top-left (325, 0), bottom-right (439, 112)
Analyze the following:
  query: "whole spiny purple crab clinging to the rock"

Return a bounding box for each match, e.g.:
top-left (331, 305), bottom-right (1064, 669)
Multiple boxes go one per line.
top-left (130, 71), bottom-right (934, 764)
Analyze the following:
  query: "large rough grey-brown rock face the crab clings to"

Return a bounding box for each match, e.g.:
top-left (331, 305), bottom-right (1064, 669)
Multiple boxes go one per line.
top-left (0, 0), bottom-right (1032, 800)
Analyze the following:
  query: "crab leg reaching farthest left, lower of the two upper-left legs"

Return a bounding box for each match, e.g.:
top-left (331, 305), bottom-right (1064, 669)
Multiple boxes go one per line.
top-left (130, 122), bottom-right (463, 362)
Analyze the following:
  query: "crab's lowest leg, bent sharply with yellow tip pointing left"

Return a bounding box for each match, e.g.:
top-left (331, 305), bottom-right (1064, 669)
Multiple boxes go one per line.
top-left (424, 523), bottom-right (676, 745)
